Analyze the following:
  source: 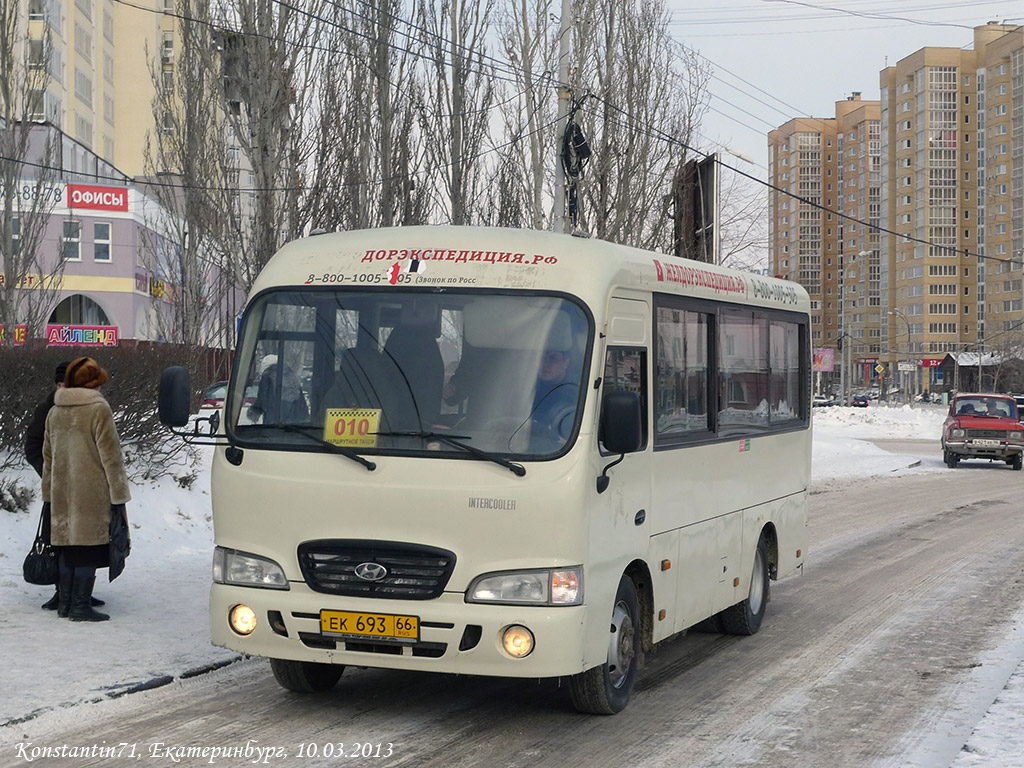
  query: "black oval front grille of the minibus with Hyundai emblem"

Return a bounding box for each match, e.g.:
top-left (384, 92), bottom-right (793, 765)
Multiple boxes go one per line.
top-left (299, 539), bottom-right (455, 600)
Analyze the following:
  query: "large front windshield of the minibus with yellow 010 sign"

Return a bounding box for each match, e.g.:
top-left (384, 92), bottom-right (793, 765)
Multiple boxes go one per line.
top-left (227, 288), bottom-right (593, 459)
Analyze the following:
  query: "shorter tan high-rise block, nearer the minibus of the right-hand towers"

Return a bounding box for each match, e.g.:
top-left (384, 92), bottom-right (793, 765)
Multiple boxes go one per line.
top-left (768, 93), bottom-right (882, 392)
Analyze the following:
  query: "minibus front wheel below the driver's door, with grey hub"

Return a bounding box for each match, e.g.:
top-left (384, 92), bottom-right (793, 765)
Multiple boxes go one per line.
top-left (569, 575), bottom-right (640, 715)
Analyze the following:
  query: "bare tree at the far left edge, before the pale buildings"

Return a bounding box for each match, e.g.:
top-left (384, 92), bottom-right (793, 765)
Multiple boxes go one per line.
top-left (0, 0), bottom-right (65, 344)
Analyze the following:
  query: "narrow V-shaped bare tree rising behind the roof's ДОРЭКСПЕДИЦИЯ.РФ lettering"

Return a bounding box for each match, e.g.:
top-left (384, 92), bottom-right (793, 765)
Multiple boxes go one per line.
top-left (418, 0), bottom-right (494, 224)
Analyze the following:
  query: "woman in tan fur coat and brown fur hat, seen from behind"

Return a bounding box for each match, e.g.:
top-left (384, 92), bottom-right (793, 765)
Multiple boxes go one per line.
top-left (43, 357), bottom-right (131, 622)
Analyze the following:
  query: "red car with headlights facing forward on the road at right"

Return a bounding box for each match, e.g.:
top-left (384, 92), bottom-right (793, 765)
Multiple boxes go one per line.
top-left (942, 394), bottom-right (1024, 470)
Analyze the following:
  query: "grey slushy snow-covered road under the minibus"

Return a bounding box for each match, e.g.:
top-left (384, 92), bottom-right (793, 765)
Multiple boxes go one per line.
top-left (8, 466), bottom-right (1024, 768)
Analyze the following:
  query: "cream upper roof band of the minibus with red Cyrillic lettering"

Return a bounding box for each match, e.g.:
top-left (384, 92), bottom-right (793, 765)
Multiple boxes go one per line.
top-left (253, 226), bottom-right (810, 313)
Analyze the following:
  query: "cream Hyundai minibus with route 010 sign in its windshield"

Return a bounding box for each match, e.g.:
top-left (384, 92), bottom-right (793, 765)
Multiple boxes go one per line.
top-left (161, 226), bottom-right (811, 714)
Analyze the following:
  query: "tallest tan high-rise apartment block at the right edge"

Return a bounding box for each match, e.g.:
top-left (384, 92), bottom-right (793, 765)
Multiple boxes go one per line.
top-left (880, 23), bottom-right (1024, 393)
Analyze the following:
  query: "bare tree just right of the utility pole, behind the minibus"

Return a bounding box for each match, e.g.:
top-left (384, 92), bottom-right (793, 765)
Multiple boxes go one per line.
top-left (572, 0), bottom-right (710, 251)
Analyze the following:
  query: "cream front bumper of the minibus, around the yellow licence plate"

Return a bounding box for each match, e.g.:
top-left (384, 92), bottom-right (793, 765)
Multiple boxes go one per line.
top-left (210, 582), bottom-right (589, 678)
